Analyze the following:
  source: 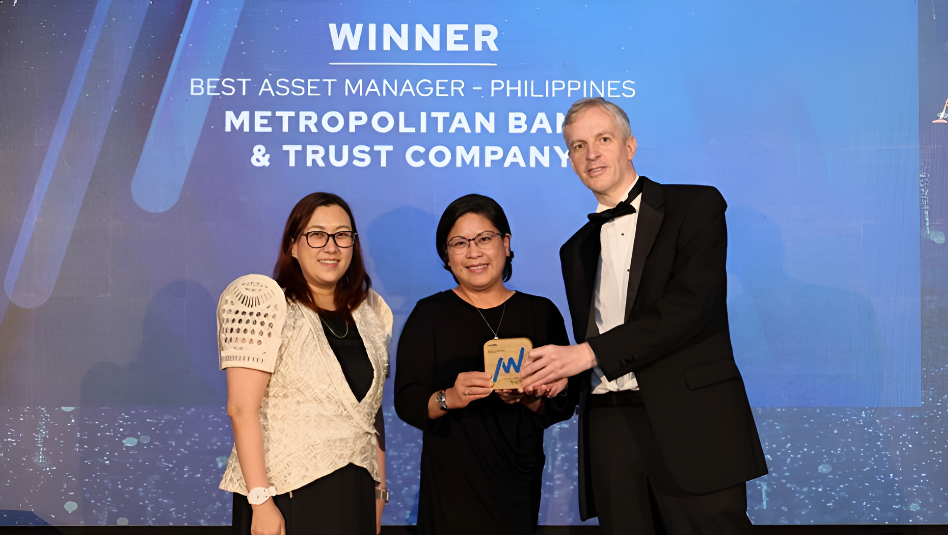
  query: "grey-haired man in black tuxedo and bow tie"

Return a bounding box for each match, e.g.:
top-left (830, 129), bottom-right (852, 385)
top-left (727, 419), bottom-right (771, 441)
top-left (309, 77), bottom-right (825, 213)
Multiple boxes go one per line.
top-left (520, 98), bottom-right (767, 535)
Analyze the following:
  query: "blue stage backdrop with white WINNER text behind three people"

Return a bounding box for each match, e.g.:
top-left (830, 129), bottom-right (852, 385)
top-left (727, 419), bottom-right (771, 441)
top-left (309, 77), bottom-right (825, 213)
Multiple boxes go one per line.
top-left (0, 0), bottom-right (936, 525)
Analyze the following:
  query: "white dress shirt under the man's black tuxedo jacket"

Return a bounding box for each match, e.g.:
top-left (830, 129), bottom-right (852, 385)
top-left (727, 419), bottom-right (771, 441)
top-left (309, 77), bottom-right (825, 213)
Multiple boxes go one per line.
top-left (590, 179), bottom-right (642, 394)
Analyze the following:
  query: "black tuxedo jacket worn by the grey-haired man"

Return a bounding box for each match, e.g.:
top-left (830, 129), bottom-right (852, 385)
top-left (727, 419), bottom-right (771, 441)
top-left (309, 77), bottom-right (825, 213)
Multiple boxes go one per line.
top-left (560, 177), bottom-right (767, 520)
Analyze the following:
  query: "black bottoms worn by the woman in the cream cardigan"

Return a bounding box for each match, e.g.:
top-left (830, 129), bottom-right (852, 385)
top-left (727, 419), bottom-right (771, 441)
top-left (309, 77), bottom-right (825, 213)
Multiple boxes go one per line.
top-left (232, 464), bottom-right (375, 535)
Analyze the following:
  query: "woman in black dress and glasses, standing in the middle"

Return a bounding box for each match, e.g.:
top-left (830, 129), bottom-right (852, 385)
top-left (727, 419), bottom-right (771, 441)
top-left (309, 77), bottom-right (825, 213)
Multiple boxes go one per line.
top-left (395, 195), bottom-right (578, 535)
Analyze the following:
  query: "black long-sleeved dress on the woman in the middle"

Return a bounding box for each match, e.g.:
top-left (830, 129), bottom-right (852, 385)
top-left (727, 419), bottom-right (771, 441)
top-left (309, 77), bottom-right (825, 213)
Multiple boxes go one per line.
top-left (395, 290), bottom-right (577, 535)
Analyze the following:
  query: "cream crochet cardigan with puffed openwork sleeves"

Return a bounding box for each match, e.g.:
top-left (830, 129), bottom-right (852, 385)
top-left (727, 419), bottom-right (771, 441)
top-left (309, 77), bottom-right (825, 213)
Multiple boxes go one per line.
top-left (218, 275), bottom-right (393, 495)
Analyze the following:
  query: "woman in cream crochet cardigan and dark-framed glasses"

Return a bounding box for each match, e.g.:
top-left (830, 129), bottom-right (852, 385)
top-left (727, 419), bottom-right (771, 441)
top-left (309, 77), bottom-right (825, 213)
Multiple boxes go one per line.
top-left (218, 193), bottom-right (392, 535)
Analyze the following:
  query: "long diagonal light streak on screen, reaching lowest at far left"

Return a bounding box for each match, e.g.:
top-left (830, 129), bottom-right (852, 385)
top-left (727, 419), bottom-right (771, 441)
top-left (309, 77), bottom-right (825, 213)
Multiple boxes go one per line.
top-left (3, 0), bottom-right (149, 308)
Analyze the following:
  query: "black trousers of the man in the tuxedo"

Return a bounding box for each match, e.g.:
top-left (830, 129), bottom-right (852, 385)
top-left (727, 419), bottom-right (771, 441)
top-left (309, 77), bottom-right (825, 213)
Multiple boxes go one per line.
top-left (587, 395), bottom-right (753, 535)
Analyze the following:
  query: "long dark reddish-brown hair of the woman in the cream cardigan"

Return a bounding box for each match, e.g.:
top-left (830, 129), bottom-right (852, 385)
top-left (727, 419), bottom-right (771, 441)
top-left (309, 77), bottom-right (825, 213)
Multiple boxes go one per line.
top-left (273, 192), bottom-right (372, 319)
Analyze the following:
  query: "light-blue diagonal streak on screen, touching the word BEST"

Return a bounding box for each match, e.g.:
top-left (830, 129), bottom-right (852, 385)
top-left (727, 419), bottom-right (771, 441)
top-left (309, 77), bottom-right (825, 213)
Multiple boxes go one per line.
top-left (132, 0), bottom-right (244, 212)
